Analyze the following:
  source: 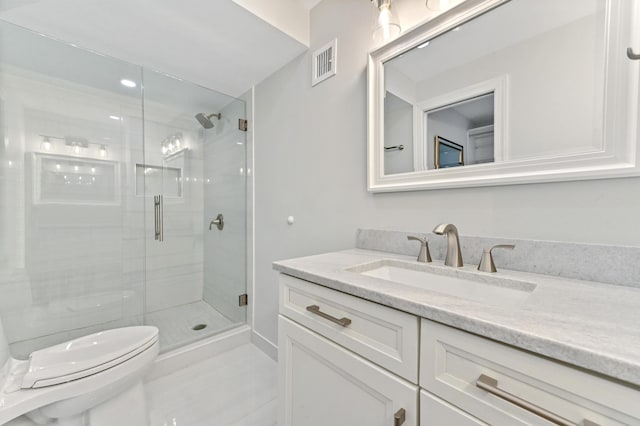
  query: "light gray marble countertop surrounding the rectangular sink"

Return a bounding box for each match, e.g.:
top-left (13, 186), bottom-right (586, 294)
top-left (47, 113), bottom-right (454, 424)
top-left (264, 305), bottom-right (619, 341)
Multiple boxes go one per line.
top-left (273, 249), bottom-right (640, 386)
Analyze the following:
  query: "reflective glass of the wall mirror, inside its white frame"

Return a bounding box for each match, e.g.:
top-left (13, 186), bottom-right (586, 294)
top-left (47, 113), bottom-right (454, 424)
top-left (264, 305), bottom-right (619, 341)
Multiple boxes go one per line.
top-left (381, 0), bottom-right (606, 175)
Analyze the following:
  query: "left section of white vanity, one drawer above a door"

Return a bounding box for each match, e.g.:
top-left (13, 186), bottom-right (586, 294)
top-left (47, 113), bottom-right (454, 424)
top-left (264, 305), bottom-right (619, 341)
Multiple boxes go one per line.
top-left (278, 275), bottom-right (419, 426)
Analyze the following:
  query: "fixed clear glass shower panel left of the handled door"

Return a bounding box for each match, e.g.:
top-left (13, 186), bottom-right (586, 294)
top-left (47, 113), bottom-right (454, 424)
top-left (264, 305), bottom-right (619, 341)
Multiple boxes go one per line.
top-left (0, 21), bottom-right (145, 358)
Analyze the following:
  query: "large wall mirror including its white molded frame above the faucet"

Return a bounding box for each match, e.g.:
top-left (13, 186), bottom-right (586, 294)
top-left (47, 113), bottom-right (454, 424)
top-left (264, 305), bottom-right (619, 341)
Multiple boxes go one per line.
top-left (368, 0), bottom-right (640, 192)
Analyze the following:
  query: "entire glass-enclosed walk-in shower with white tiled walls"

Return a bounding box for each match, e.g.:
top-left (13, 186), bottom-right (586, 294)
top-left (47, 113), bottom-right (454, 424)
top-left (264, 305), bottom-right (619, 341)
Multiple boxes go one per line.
top-left (0, 21), bottom-right (246, 358)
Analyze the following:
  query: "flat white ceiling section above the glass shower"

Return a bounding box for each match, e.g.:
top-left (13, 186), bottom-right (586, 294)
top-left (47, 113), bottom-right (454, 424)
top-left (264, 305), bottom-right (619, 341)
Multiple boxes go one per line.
top-left (0, 0), bottom-right (318, 97)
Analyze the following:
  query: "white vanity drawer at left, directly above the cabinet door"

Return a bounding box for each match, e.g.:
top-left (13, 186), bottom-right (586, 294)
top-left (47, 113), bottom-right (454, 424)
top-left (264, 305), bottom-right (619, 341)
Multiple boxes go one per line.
top-left (280, 274), bottom-right (419, 383)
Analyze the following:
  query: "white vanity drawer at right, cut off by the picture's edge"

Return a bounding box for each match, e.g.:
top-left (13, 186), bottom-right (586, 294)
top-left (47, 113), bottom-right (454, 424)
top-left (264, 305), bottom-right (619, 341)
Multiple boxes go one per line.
top-left (420, 320), bottom-right (640, 426)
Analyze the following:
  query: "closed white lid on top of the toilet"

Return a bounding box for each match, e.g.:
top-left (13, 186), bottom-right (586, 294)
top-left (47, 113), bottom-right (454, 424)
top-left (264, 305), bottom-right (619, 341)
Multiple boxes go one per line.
top-left (22, 326), bottom-right (158, 389)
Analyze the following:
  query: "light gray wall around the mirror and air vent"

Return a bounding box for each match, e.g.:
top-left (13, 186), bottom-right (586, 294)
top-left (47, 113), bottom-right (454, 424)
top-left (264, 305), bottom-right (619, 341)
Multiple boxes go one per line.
top-left (254, 0), bottom-right (640, 350)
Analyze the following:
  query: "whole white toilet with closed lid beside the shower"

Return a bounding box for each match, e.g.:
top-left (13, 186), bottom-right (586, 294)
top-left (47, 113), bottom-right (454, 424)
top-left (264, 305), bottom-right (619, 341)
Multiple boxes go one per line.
top-left (0, 322), bottom-right (158, 426)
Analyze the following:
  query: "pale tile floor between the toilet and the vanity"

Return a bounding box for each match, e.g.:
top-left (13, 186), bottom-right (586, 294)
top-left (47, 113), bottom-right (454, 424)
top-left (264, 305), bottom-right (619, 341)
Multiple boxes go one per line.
top-left (5, 344), bottom-right (277, 426)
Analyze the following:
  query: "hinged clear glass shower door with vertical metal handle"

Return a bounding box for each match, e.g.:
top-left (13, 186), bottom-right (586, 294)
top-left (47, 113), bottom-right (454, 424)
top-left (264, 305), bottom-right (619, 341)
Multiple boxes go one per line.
top-left (141, 70), bottom-right (246, 351)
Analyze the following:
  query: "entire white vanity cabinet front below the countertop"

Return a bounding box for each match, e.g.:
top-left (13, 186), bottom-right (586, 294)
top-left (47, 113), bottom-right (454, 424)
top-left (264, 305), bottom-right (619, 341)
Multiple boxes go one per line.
top-left (278, 274), bottom-right (640, 426)
